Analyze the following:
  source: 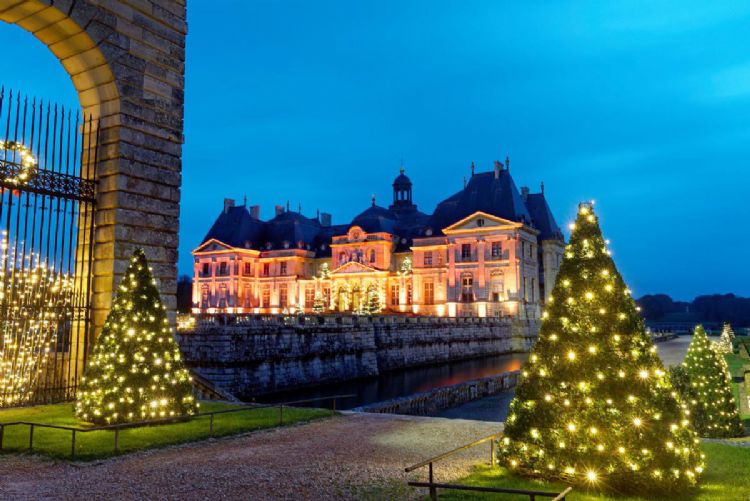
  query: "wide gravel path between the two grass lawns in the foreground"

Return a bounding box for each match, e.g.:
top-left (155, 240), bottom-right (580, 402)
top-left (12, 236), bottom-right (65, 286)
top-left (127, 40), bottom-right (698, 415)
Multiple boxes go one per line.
top-left (0, 414), bottom-right (501, 500)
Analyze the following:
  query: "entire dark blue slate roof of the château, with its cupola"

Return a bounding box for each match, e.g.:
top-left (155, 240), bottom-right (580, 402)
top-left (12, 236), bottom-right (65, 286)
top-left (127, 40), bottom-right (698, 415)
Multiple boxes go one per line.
top-left (202, 165), bottom-right (563, 257)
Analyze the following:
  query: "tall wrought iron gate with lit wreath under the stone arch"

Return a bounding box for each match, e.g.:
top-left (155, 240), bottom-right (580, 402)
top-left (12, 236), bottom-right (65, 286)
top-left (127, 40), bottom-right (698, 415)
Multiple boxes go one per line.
top-left (0, 88), bottom-right (98, 407)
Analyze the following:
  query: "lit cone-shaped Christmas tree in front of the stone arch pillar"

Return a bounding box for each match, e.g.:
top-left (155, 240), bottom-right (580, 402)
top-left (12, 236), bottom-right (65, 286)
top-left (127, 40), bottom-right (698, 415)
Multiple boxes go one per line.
top-left (76, 249), bottom-right (198, 424)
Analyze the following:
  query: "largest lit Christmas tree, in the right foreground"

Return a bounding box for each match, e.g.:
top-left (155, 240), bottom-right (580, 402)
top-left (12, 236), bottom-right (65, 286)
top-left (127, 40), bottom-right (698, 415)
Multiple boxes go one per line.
top-left (498, 204), bottom-right (703, 493)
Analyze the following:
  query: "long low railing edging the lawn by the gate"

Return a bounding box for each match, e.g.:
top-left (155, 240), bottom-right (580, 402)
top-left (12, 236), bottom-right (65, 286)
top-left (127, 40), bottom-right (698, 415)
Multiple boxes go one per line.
top-left (0, 394), bottom-right (356, 457)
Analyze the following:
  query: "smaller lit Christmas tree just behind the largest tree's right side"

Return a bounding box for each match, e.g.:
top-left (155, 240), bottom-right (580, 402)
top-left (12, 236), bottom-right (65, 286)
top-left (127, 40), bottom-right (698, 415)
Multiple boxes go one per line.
top-left (683, 325), bottom-right (743, 438)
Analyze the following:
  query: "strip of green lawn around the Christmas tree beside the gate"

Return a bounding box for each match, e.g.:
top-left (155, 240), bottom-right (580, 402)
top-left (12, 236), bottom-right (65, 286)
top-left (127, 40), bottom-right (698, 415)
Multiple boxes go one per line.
top-left (0, 402), bottom-right (331, 460)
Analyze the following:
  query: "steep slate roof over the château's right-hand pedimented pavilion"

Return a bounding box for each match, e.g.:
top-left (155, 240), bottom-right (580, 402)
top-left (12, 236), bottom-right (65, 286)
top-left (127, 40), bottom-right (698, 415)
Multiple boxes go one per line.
top-left (428, 168), bottom-right (532, 233)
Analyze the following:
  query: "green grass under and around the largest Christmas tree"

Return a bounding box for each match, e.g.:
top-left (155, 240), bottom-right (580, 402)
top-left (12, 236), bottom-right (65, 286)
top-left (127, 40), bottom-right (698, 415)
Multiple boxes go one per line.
top-left (435, 444), bottom-right (750, 501)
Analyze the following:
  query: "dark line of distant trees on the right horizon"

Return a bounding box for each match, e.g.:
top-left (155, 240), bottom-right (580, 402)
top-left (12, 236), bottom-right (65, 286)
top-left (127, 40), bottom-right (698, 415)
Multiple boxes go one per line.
top-left (636, 294), bottom-right (750, 327)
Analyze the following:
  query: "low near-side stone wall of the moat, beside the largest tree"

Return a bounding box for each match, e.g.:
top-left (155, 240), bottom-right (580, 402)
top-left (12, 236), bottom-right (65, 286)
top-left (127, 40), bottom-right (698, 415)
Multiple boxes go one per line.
top-left (352, 371), bottom-right (520, 416)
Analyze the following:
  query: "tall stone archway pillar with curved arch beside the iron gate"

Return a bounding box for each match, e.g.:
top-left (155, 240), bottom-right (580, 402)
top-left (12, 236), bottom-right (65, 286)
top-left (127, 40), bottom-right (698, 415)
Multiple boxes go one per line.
top-left (0, 0), bottom-right (187, 332)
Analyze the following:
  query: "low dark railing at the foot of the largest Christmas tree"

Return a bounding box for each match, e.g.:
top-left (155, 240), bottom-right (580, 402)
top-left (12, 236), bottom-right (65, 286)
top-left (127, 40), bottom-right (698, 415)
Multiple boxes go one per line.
top-left (404, 433), bottom-right (573, 501)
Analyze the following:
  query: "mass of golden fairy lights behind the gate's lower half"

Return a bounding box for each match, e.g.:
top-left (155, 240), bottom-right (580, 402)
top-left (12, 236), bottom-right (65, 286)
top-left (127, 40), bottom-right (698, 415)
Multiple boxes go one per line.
top-left (0, 232), bottom-right (73, 407)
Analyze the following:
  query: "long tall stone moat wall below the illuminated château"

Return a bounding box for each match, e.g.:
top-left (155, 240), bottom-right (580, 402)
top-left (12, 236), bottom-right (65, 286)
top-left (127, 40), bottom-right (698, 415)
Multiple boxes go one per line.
top-left (177, 316), bottom-right (538, 396)
